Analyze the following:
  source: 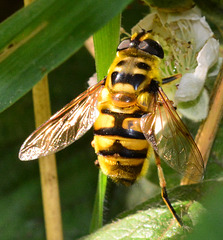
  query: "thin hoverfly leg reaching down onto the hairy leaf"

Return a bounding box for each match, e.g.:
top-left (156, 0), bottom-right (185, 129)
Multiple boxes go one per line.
top-left (154, 151), bottom-right (183, 227)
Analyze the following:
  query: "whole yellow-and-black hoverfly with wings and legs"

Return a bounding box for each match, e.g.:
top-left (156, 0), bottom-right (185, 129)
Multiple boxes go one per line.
top-left (19, 31), bottom-right (204, 225)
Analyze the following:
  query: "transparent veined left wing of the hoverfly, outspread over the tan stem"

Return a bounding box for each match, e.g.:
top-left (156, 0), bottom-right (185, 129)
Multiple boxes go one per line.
top-left (19, 80), bottom-right (104, 160)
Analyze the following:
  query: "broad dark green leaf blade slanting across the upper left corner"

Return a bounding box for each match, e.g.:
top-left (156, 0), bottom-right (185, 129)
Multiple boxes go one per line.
top-left (0, 0), bottom-right (131, 111)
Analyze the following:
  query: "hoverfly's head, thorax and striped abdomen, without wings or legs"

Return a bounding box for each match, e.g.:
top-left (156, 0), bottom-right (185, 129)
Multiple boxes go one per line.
top-left (92, 33), bottom-right (163, 185)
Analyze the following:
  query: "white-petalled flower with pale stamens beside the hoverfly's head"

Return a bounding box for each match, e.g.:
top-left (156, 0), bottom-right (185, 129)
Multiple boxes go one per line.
top-left (132, 7), bottom-right (219, 121)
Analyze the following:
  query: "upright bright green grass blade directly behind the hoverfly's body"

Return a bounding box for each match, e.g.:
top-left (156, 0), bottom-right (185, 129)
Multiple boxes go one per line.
top-left (90, 15), bottom-right (121, 232)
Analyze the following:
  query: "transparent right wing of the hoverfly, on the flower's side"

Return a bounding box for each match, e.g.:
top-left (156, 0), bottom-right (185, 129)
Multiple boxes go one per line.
top-left (141, 87), bottom-right (204, 182)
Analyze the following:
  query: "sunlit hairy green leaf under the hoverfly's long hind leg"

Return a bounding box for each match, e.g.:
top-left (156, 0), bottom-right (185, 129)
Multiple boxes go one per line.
top-left (84, 181), bottom-right (222, 240)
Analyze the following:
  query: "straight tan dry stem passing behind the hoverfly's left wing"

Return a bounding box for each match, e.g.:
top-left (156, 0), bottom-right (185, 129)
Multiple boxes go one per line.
top-left (33, 77), bottom-right (63, 240)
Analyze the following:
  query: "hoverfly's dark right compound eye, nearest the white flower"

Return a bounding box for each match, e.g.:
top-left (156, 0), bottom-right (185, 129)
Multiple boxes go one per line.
top-left (138, 39), bottom-right (164, 58)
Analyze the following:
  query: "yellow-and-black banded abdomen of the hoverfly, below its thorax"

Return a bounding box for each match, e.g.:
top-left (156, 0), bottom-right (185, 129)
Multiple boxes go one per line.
top-left (93, 104), bottom-right (148, 185)
